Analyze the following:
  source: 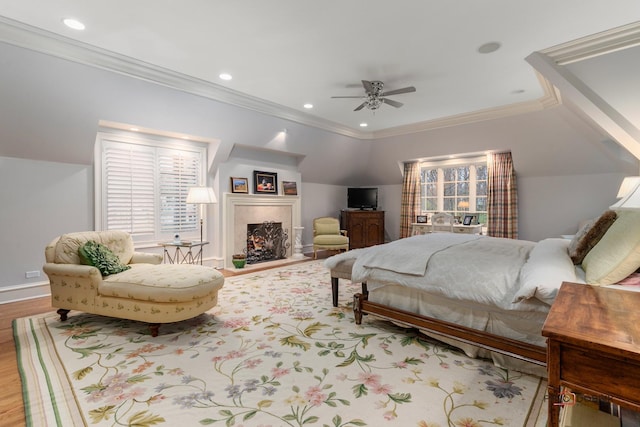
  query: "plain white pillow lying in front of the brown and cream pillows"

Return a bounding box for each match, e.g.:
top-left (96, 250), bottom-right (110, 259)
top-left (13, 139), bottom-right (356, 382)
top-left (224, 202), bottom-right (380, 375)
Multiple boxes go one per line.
top-left (513, 238), bottom-right (577, 305)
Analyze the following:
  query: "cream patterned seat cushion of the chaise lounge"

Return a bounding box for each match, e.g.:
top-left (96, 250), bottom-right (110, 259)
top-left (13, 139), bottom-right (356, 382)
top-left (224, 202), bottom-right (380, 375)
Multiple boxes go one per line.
top-left (98, 264), bottom-right (224, 303)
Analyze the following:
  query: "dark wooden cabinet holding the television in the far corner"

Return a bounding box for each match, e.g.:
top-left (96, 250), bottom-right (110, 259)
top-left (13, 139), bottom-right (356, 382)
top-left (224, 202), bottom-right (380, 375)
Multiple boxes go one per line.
top-left (340, 210), bottom-right (384, 249)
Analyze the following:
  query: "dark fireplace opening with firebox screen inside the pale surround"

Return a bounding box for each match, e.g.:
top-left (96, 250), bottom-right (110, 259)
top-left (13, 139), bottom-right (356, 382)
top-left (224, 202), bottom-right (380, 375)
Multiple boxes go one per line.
top-left (246, 221), bottom-right (291, 264)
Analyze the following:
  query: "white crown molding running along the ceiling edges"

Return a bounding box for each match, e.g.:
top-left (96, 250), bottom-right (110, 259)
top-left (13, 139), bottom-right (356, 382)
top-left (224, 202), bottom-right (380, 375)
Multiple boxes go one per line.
top-left (0, 16), bottom-right (640, 139)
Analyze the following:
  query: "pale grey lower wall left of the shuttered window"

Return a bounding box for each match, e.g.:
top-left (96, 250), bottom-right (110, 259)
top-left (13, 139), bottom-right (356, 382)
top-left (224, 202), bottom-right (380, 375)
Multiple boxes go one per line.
top-left (0, 157), bottom-right (93, 302)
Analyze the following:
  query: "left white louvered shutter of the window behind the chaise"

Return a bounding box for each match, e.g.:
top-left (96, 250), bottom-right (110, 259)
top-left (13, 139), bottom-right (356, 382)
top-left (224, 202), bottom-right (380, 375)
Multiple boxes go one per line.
top-left (102, 141), bottom-right (156, 237)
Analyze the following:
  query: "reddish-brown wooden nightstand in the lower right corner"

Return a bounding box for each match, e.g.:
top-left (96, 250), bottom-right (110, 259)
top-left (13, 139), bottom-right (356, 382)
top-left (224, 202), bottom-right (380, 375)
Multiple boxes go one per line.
top-left (542, 282), bottom-right (640, 427)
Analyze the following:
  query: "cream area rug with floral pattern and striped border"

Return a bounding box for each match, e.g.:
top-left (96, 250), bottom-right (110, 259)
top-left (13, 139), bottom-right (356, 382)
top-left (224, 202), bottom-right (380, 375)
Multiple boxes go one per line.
top-left (14, 261), bottom-right (546, 427)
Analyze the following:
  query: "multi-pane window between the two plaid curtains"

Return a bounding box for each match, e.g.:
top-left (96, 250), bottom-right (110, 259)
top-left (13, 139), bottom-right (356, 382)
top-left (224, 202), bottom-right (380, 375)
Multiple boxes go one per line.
top-left (420, 157), bottom-right (487, 224)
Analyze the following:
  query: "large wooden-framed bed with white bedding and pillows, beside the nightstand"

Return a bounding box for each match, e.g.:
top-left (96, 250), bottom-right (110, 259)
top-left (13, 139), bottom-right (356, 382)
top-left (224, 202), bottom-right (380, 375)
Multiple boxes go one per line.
top-left (325, 211), bottom-right (640, 374)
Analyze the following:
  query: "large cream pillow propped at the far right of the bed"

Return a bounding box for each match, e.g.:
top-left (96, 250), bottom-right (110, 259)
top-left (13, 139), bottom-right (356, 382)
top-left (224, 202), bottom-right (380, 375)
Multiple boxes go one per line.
top-left (582, 210), bottom-right (640, 285)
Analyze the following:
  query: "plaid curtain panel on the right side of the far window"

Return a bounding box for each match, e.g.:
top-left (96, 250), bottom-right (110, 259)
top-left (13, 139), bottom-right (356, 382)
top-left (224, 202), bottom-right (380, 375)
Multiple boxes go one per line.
top-left (487, 152), bottom-right (518, 239)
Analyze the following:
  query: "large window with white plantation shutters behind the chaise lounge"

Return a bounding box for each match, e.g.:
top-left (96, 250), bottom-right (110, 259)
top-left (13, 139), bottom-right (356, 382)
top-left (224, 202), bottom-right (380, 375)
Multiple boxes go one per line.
top-left (96, 133), bottom-right (206, 242)
